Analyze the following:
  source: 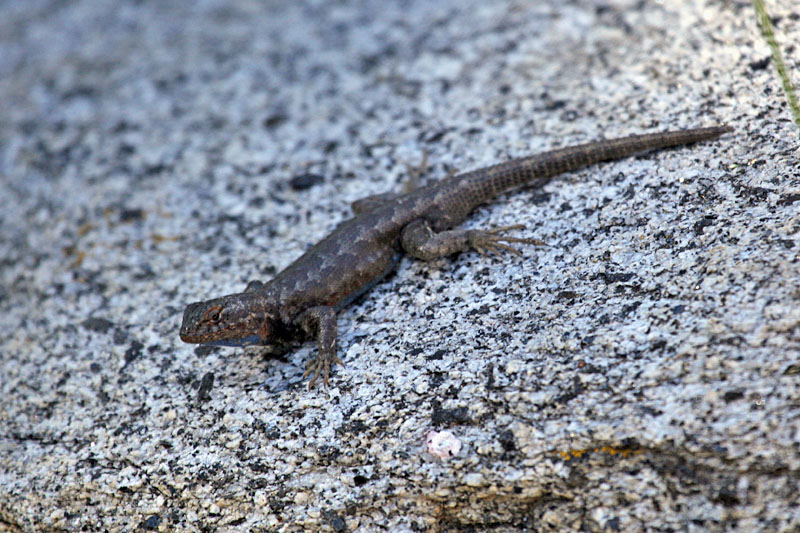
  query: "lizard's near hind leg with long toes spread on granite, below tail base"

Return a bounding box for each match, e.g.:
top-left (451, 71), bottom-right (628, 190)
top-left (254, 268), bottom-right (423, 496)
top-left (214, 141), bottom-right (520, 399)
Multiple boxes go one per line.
top-left (400, 219), bottom-right (544, 261)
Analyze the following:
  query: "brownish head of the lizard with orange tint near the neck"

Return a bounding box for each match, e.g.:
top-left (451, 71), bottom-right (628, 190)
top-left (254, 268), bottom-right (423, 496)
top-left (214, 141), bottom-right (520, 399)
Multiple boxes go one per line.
top-left (181, 292), bottom-right (276, 346)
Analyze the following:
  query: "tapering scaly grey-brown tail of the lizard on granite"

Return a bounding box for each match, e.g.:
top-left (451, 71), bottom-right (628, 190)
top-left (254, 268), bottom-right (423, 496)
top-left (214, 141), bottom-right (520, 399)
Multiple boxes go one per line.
top-left (461, 126), bottom-right (733, 198)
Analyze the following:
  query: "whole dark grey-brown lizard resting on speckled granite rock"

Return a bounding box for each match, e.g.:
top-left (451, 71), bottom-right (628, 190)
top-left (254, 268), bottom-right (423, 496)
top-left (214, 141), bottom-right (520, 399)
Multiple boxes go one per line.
top-left (180, 126), bottom-right (732, 389)
